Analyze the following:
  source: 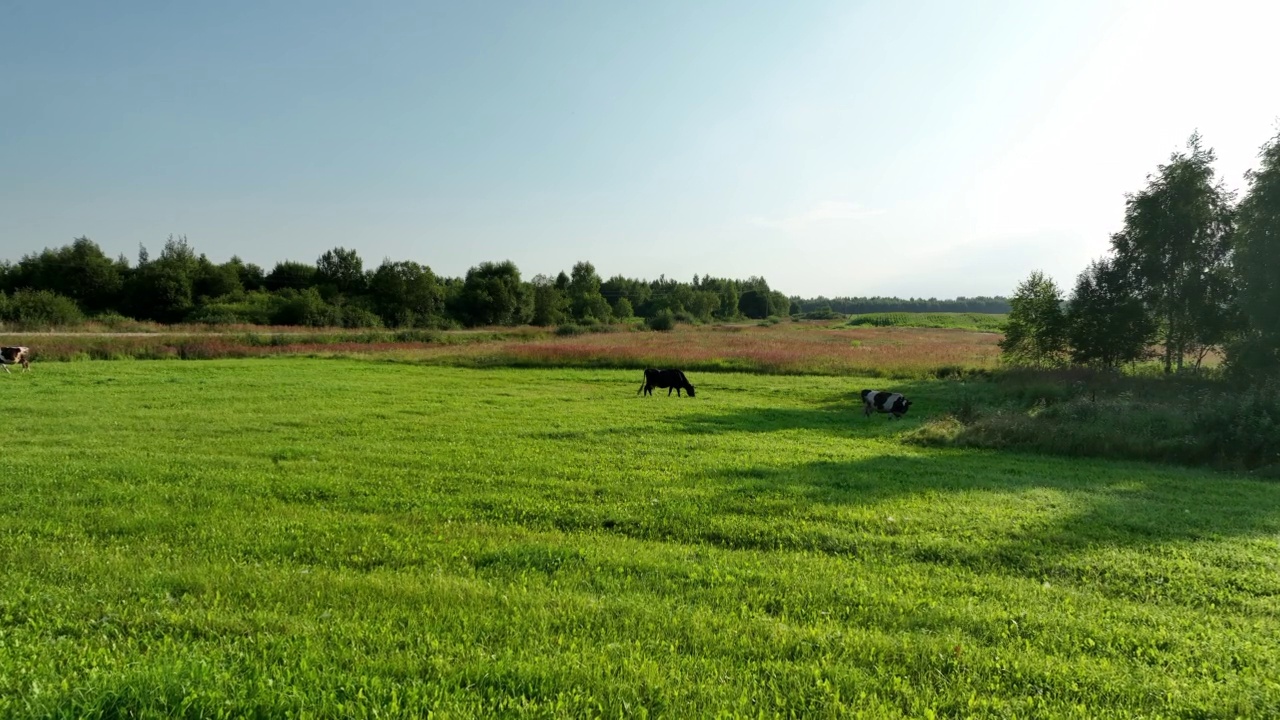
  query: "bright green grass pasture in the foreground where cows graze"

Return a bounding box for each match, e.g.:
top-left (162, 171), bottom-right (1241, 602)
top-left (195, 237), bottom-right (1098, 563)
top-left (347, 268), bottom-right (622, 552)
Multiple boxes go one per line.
top-left (0, 357), bottom-right (1280, 717)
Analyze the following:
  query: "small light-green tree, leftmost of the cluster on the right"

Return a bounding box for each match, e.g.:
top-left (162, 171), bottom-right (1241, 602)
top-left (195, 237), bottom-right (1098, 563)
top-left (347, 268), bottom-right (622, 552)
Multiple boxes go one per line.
top-left (1000, 270), bottom-right (1066, 368)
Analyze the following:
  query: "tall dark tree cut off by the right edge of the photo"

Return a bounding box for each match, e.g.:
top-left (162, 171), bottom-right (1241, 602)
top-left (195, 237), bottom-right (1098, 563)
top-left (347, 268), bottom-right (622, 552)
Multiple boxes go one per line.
top-left (1228, 135), bottom-right (1280, 377)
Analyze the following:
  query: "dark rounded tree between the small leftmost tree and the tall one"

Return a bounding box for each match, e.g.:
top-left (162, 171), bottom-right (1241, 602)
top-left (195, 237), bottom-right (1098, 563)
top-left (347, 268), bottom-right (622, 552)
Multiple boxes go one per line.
top-left (1066, 259), bottom-right (1156, 368)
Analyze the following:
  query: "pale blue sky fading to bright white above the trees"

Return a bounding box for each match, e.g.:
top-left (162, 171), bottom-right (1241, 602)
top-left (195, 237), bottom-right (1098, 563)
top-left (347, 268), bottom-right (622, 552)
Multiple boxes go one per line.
top-left (0, 0), bottom-right (1280, 297)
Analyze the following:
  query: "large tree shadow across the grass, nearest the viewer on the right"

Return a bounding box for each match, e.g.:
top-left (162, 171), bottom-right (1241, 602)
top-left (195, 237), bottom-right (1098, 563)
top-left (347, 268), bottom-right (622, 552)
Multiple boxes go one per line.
top-left (716, 451), bottom-right (1280, 558)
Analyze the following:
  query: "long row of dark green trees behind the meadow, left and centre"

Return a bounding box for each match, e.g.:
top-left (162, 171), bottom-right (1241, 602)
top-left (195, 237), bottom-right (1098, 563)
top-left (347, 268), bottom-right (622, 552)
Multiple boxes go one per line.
top-left (0, 236), bottom-right (791, 328)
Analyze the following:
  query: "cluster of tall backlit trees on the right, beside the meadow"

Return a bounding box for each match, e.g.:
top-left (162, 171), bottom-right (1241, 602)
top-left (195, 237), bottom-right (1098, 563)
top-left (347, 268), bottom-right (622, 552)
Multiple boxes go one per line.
top-left (1001, 133), bottom-right (1280, 377)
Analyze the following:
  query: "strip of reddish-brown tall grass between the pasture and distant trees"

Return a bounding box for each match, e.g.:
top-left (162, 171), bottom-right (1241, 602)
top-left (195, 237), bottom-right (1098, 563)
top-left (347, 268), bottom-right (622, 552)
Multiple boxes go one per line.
top-left (6, 322), bottom-right (1000, 378)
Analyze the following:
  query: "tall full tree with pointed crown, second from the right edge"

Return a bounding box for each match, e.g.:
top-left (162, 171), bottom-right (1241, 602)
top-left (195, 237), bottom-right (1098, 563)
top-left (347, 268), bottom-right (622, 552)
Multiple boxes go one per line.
top-left (1111, 133), bottom-right (1233, 373)
